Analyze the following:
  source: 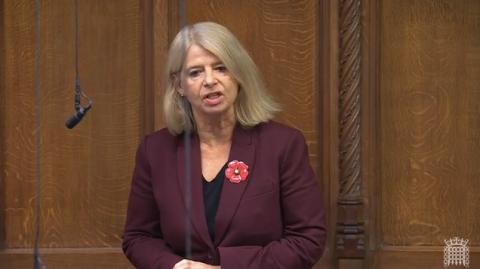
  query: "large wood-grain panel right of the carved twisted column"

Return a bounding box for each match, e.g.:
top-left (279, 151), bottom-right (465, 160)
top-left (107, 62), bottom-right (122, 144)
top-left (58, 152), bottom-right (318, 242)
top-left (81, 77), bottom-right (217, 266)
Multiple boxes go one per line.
top-left (379, 0), bottom-right (480, 246)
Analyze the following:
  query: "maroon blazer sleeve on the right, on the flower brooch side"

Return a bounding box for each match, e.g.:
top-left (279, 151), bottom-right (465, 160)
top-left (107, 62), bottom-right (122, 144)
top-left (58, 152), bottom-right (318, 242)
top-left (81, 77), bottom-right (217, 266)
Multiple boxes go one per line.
top-left (218, 131), bottom-right (326, 269)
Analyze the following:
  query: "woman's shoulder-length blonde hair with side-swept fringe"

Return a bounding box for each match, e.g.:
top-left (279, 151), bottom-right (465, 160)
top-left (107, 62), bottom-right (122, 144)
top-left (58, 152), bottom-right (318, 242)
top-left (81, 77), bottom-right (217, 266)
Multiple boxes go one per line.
top-left (163, 22), bottom-right (280, 135)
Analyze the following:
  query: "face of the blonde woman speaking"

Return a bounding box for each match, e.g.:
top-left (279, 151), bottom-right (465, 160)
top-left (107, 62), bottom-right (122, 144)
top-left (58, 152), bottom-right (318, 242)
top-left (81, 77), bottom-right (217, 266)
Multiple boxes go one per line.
top-left (179, 45), bottom-right (238, 119)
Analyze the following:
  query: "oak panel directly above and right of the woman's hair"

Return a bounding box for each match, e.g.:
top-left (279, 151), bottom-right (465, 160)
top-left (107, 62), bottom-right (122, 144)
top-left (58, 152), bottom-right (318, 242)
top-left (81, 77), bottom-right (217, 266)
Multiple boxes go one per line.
top-left (186, 0), bottom-right (319, 170)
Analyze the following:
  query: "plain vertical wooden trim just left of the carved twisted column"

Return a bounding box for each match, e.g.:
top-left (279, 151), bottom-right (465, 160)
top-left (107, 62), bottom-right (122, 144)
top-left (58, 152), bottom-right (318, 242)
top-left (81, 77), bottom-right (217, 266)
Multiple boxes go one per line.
top-left (315, 1), bottom-right (338, 268)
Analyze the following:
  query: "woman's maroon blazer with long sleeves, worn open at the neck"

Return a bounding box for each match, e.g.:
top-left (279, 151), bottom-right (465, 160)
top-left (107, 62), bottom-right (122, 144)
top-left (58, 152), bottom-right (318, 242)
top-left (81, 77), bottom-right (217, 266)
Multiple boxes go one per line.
top-left (123, 122), bottom-right (326, 269)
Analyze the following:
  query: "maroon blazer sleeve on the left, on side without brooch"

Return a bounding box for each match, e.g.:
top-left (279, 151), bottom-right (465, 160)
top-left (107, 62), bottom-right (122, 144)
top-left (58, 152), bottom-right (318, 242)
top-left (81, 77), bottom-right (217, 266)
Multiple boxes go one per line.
top-left (122, 137), bottom-right (183, 269)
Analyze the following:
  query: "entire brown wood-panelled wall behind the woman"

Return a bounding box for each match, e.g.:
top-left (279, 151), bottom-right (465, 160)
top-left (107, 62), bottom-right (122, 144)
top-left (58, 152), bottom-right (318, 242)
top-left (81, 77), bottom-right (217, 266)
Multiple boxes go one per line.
top-left (0, 0), bottom-right (480, 269)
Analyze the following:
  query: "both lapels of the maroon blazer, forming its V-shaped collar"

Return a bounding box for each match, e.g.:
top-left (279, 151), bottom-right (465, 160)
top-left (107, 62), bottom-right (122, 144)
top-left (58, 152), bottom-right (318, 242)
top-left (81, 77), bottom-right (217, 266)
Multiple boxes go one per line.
top-left (177, 124), bottom-right (255, 247)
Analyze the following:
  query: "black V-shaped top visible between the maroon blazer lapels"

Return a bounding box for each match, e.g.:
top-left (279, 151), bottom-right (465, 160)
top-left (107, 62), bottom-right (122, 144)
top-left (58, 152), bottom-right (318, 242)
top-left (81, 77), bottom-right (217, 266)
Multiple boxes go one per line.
top-left (202, 165), bottom-right (226, 241)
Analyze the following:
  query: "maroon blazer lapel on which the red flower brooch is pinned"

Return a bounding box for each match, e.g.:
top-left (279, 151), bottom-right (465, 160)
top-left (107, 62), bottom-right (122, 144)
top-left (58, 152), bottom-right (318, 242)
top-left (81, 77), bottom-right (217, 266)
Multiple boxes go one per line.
top-left (215, 124), bottom-right (255, 245)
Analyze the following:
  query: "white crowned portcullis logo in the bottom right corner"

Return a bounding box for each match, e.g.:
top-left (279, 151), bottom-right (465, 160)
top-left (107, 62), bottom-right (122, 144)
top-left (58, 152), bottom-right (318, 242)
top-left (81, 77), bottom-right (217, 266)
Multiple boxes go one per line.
top-left (443, 237), bottom-right (470, 268)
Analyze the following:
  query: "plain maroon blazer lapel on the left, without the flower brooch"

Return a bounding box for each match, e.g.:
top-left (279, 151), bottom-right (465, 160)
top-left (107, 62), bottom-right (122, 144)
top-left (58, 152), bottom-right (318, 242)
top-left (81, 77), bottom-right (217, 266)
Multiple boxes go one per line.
top-left (177, 132), bottom-right (212, 246)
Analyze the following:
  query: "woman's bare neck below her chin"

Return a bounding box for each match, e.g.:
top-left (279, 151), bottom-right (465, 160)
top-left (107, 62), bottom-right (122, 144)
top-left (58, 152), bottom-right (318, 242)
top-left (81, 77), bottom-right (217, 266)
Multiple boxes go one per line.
top-left (195, 110), bottom-right (236, 146)
